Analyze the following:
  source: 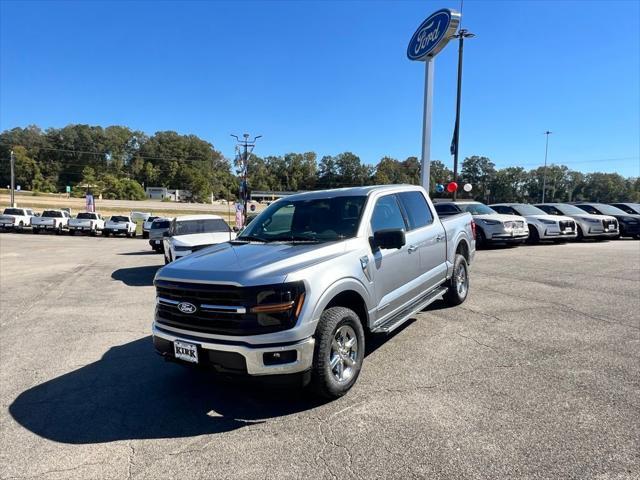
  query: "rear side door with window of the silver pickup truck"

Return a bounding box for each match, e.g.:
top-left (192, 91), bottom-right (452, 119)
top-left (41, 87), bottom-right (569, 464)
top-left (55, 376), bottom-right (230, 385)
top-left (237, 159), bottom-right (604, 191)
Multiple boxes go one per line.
top-left (397, 190), bottom-right (447, 295)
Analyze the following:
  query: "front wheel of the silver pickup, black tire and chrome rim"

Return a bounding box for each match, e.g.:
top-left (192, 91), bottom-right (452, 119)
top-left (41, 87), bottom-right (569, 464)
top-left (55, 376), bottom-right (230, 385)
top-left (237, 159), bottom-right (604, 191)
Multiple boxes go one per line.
top-left (311, 307), bottom-right (365, 399)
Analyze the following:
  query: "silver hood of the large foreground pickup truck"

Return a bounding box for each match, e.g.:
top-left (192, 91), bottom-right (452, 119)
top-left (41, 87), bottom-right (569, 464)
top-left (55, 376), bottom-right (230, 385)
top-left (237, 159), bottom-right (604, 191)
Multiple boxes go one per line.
top-left (156, 241), bottom-right (347, 286)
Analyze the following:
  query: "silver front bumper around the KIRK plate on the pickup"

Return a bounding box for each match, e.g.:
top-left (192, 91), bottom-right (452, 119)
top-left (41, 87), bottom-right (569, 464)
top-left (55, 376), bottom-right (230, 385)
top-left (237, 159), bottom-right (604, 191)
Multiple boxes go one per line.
top-left (152, 322), bottom-right (315, 376)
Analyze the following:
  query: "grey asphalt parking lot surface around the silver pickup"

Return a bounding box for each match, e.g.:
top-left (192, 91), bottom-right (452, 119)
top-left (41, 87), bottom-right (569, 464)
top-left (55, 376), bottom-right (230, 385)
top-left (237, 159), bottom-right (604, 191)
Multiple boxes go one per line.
top-left (0, 233), bottom-right (640, 479)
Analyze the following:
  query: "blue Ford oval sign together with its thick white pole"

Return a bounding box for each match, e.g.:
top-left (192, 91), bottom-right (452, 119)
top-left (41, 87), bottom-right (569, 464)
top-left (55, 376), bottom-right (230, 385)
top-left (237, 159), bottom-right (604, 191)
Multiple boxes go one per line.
top-left (407, 8), bottom-right (460, 192)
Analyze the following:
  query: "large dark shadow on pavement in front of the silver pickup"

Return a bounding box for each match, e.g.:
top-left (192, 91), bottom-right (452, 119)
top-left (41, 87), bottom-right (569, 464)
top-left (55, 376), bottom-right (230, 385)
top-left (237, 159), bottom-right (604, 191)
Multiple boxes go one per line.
top-left (9, 337), bottom-right (324, 444)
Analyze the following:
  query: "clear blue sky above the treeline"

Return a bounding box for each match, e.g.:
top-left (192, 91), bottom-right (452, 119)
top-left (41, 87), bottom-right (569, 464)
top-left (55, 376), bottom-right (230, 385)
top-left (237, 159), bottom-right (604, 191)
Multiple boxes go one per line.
top-left (0, 0), bottom-right (640, 176)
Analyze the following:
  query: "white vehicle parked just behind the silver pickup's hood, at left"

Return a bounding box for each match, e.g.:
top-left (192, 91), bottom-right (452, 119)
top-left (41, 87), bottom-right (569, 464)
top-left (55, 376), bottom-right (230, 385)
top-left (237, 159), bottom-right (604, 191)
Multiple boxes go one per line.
top-left (164, 215), bottom-right (236, 264)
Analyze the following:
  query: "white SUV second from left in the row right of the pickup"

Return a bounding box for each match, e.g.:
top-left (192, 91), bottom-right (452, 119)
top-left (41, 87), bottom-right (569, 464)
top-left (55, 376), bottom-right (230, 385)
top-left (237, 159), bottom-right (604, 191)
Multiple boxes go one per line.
top-left (489, 203), bottom-right (578, 243)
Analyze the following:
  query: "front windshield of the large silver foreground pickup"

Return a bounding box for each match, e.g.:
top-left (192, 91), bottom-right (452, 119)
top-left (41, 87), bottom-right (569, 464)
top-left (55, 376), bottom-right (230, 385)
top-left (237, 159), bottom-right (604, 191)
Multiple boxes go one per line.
top-left (238, 196), bottom-right (367, 242)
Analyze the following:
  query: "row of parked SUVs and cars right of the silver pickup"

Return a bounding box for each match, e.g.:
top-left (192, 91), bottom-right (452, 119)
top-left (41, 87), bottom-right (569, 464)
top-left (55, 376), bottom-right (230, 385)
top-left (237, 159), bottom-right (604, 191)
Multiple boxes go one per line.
top-left (435, 200), bottom-right (640, 245)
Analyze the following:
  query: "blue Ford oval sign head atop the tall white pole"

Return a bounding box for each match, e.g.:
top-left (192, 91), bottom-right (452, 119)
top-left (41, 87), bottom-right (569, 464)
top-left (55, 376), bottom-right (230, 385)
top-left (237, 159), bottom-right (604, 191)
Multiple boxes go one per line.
top-left (407, 8), bottom-right (460, 60)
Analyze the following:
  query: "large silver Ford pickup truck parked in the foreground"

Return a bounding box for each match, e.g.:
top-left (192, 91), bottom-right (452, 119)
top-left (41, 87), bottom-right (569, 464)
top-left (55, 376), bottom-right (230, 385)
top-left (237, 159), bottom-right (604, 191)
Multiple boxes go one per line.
top-left (152, 185), bottom-right (475, 398)
